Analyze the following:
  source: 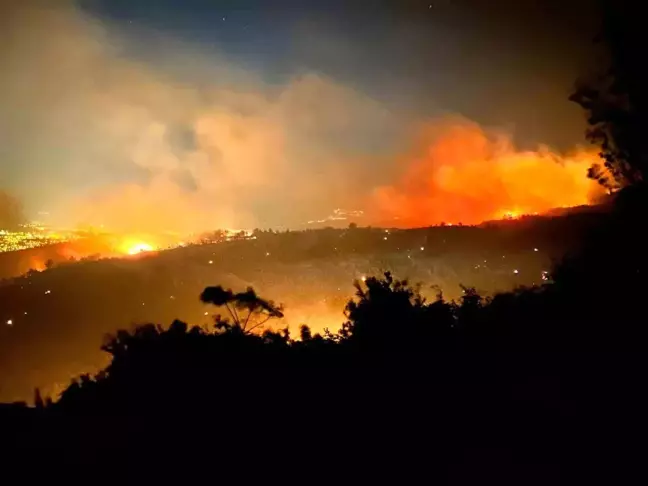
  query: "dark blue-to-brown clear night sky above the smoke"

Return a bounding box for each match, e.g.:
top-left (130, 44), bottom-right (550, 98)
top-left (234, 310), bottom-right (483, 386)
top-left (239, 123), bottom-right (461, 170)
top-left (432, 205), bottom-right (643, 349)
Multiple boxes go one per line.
top-left (82, 0), bottom-right (597, 148)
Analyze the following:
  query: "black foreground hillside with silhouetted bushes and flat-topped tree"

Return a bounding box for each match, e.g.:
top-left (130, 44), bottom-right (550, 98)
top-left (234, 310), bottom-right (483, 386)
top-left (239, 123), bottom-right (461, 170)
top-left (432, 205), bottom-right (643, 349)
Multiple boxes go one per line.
top-left (0, 275), bottom-right (645, 485)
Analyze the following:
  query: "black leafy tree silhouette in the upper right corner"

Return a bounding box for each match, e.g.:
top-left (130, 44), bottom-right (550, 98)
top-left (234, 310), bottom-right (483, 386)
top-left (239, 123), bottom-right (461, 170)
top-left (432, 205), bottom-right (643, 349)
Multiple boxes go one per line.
top-left (570, 0), bottom-right (648, 191)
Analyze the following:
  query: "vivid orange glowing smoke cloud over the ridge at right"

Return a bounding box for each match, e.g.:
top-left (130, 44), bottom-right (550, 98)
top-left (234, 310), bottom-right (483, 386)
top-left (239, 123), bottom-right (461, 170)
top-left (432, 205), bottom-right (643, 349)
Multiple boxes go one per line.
top-left (371, 119), bottom-right (603, 227)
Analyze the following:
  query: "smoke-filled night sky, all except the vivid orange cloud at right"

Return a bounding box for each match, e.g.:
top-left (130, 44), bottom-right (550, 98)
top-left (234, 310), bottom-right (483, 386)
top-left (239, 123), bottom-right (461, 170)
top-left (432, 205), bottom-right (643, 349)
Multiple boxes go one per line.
top-left (0, 0), bottom-right (597, 225)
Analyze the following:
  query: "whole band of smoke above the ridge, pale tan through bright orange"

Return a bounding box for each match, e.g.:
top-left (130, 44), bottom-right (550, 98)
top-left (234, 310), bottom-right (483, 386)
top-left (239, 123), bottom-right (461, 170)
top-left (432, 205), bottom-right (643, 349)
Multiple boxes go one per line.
top-left (0, 0), bottom-right (604, 232)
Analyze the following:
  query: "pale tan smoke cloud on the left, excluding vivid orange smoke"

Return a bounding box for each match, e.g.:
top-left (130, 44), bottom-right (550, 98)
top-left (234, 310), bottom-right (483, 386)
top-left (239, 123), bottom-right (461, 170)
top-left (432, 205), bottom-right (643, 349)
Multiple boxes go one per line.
top-left (0, 1), bottom-right (392, 232)
